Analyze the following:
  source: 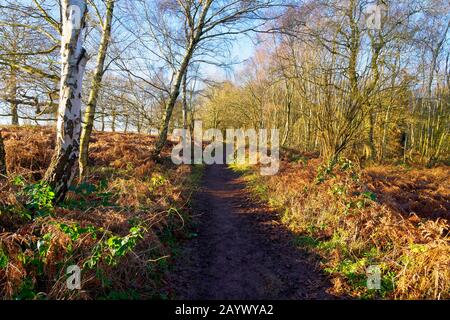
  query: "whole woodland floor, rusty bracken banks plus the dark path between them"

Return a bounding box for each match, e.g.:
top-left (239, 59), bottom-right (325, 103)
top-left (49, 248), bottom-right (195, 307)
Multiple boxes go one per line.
top-left (0, 127), bottom-right (450, 300)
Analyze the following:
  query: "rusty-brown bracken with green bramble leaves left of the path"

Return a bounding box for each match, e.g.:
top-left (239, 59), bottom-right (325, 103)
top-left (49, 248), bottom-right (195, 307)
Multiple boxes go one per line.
top-left (0, 127), bottom-right (198, 299)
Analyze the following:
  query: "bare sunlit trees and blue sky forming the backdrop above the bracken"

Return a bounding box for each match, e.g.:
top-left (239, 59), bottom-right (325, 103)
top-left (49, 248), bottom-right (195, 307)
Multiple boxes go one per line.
top-left (1, 0), bottom-right (450, 172)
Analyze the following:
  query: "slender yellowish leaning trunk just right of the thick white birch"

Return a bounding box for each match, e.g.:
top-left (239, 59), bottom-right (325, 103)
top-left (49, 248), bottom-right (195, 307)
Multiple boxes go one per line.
top-left (79, 0), bottom-right (115, 178)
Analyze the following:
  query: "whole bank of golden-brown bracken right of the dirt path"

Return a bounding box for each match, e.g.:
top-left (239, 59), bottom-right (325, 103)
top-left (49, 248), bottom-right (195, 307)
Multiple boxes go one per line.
top-left (247, 158), bottom-right (450, 299)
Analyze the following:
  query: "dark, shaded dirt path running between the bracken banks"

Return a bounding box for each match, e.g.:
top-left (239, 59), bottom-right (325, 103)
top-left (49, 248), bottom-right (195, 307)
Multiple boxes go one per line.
top-left (168, 165), bottom-right (331, 299)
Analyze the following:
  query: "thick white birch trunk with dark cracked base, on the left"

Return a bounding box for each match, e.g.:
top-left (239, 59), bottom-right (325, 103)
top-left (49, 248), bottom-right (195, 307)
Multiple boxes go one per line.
top-left (44, 0), bottom-right (88, 202)
